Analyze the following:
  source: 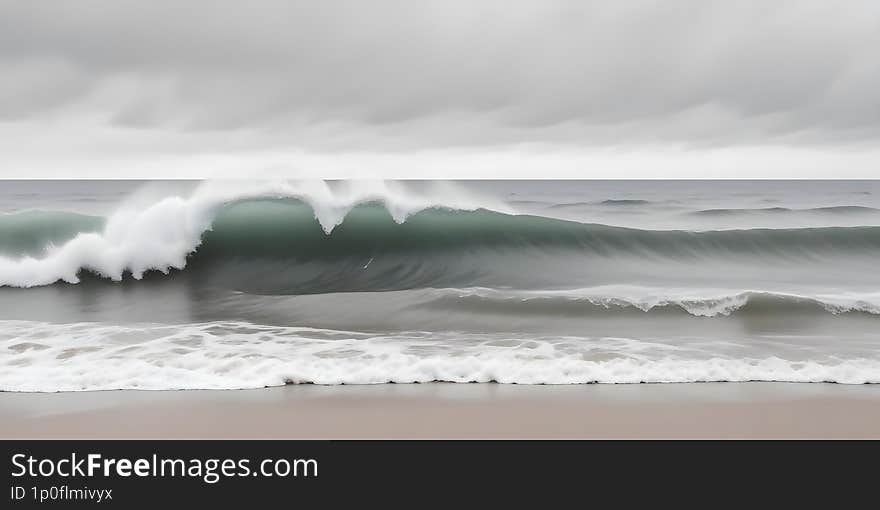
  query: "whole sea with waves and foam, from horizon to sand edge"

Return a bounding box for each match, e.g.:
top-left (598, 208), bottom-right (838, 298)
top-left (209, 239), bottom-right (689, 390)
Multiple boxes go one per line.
top-left (0, 181), bottom-right (880, 392)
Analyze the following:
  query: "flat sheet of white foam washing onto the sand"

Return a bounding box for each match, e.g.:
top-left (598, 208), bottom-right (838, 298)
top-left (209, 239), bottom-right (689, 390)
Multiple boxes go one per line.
top-left (0, 321), bottom-right (880, 392)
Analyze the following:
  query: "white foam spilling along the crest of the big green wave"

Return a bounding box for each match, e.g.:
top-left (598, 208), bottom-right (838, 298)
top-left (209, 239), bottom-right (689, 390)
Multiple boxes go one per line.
top-left (0, 181), bottom-right (508, 287)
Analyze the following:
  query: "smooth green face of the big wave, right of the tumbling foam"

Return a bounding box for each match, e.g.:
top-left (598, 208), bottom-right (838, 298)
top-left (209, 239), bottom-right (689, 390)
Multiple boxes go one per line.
top-left (197, 200), bottom-right (880, 260)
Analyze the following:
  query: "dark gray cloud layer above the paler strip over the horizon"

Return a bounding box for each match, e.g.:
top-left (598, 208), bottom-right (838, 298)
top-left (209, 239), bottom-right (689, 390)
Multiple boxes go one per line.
top-left (0, 0), bottom-right (880, 148)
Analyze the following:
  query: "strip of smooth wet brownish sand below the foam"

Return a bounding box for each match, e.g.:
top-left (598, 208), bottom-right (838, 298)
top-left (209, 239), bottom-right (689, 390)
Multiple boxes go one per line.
top-left (0, 383), bottom-right (880, 439)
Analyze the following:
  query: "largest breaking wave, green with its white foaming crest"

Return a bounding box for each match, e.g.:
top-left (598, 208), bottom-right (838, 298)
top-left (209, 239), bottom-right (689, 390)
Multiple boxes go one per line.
top-left (0, 183), bottom-right (880, 291)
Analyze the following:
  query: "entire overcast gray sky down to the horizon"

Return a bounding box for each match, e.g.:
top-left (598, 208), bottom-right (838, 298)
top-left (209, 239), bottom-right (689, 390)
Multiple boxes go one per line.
top-left (0, 0), bottom-right (880, 178)
